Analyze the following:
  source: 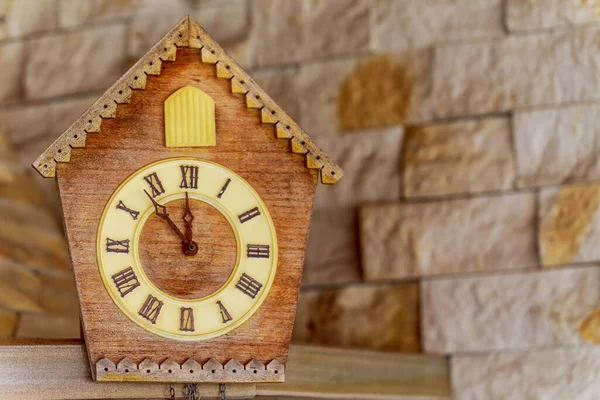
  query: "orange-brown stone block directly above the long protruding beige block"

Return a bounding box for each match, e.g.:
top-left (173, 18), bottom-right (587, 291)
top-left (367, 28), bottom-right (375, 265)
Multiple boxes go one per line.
top-left (403, 118), bottom-right (515, 197)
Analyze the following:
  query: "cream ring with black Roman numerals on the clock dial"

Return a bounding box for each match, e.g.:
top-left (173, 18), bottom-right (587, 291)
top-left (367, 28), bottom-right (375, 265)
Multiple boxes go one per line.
top-left (97, 157), bottom-right (278, 340)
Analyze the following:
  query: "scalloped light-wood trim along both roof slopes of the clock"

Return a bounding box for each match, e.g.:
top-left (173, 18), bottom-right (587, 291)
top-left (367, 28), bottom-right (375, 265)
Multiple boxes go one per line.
top-left (33, 16), bottom-right (344, 184)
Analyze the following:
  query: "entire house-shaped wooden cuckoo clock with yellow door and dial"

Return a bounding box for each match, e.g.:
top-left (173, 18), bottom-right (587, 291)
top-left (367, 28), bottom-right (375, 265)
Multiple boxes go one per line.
top-left (33, 17), bottom-right (343, 383)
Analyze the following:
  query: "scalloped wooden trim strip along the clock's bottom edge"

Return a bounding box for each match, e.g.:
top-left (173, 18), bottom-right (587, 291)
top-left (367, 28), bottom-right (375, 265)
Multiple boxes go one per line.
top-left (96, 358), bottom-right (285, 383)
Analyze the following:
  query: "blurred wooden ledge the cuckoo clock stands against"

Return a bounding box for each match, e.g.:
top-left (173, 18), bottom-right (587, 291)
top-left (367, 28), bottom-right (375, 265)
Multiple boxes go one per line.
top-left (0, 340), bottom-right (450, 400)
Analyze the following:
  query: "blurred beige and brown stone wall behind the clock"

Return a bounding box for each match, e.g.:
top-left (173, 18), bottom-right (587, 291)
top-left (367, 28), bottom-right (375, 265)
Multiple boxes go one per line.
top-left (0, 0), bottom-right (600, 398)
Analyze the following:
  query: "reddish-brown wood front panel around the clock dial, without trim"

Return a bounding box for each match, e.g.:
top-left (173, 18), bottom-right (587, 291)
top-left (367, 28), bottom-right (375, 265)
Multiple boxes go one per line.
top-left (57, 48), bottom-right (318, 376)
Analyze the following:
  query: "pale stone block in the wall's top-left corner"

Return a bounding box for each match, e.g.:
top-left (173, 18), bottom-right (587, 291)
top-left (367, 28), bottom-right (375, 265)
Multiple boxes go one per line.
top-left (0, 0), bottom-right (58, 40)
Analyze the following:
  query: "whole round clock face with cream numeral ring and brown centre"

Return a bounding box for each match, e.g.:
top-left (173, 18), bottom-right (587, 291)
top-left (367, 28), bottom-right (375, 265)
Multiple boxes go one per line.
top-left (97, 158), bottom-right (277, 340)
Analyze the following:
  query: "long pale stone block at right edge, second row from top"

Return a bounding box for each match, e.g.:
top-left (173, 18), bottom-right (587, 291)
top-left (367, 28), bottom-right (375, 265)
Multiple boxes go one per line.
top-left (433, 28), bottom-right (600, 117)
